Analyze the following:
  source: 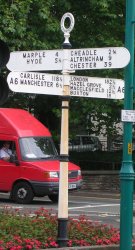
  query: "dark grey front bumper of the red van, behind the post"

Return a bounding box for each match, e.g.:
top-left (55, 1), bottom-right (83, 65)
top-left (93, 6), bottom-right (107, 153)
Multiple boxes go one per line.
top-left (30, 180), bottom-right (83, 197)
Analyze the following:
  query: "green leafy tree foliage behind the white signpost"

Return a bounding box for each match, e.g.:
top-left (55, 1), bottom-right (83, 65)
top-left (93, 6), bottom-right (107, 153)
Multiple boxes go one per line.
top-left (0, 0), bottom-right (125, 139)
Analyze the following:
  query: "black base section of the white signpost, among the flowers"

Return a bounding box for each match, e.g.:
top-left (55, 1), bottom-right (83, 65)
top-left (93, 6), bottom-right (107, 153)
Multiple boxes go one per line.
top-left (57, 218), bottom-right (68, 247)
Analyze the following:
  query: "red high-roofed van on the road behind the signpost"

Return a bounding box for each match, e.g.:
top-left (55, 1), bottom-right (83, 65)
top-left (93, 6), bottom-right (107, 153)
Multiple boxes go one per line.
top-left (0, 108), bottom-right (82, 204)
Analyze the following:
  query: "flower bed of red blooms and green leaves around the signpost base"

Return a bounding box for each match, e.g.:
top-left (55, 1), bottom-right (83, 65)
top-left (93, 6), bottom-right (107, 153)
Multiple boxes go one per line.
top-left (0, 207), bottom-right (120, 250)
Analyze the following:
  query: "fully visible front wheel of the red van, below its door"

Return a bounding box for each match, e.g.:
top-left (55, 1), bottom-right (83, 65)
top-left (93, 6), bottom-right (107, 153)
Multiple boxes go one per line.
top-left (11, 182), bottom-right (34, 204)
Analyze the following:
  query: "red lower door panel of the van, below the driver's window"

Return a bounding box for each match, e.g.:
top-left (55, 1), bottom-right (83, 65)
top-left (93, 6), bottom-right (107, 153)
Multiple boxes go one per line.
top-left (0, 159), bottom-right (20, 191)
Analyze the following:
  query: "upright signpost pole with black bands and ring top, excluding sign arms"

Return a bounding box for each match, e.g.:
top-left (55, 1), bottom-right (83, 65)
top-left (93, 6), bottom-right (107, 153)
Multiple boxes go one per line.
top-left (58, 13), bottom-right (74, 247)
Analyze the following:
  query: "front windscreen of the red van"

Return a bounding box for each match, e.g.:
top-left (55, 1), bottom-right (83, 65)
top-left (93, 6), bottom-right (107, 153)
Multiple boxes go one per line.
top-left (20, 137), bottom-right (58, 161)
